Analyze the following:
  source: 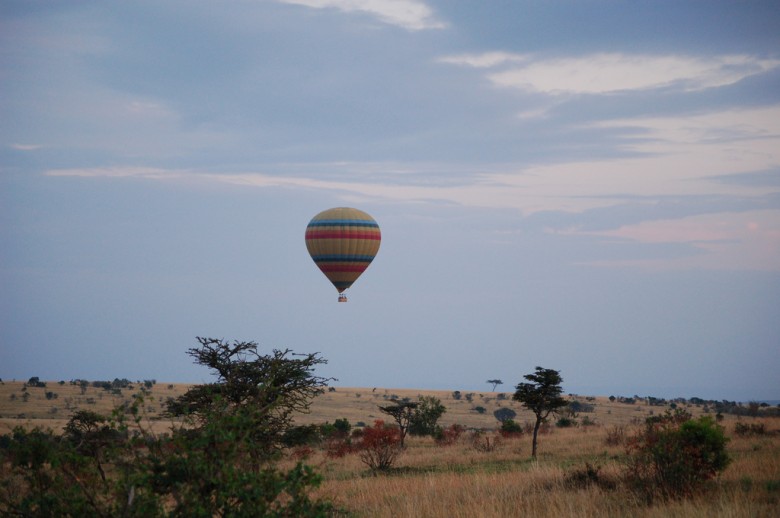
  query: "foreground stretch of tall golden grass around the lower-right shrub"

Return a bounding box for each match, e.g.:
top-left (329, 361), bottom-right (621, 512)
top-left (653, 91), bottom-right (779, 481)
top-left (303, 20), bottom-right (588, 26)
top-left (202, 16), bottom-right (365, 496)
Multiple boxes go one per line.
top-left (298, 423), bottom-right (780, 518)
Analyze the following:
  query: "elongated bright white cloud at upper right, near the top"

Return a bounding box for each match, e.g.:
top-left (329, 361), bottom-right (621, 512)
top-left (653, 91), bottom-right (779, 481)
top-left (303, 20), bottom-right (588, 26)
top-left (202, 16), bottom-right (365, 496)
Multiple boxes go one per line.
top-left (440, 52), bottom-right (780, 95)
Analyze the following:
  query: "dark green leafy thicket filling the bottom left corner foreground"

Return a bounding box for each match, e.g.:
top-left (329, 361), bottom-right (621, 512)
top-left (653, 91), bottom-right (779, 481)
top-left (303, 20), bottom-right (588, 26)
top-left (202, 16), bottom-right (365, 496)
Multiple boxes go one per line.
top-left (0, 412), bottom-right (332, 517)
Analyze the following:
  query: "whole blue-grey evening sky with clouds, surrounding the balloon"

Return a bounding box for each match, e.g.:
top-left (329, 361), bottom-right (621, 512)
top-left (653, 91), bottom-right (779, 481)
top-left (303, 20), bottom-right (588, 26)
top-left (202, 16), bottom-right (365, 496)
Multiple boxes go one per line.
top-left (0, 0), bottom-right (780, 401)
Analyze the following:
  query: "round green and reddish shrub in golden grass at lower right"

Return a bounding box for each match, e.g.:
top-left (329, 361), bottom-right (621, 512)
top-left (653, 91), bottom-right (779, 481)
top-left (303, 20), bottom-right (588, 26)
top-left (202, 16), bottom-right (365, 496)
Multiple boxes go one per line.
top-left (627, 409), bottom-right (730, 499)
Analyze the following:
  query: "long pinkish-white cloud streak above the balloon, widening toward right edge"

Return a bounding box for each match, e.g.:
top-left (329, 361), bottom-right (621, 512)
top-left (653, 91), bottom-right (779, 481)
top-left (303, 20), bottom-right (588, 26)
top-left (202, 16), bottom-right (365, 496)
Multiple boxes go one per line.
top-left (47, 101), bottom-right (780, 271)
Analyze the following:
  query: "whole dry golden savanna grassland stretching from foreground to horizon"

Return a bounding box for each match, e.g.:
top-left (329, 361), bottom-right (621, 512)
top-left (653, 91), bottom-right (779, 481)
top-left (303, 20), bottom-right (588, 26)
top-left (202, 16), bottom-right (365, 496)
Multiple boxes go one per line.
top-left (0, 381), bottom-right (780, 517)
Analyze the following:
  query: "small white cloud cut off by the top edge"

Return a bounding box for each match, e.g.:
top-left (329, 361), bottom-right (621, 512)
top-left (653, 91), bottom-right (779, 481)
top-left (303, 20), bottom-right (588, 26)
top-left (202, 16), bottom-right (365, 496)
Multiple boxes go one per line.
top-left (279, 0), bottom-right (445, 31)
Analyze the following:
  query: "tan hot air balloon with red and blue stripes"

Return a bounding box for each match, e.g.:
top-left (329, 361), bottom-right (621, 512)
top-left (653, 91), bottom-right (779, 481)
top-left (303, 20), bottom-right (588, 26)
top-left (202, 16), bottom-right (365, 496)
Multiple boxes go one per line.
top-left (306, 207), bottom-right (382, 302)
